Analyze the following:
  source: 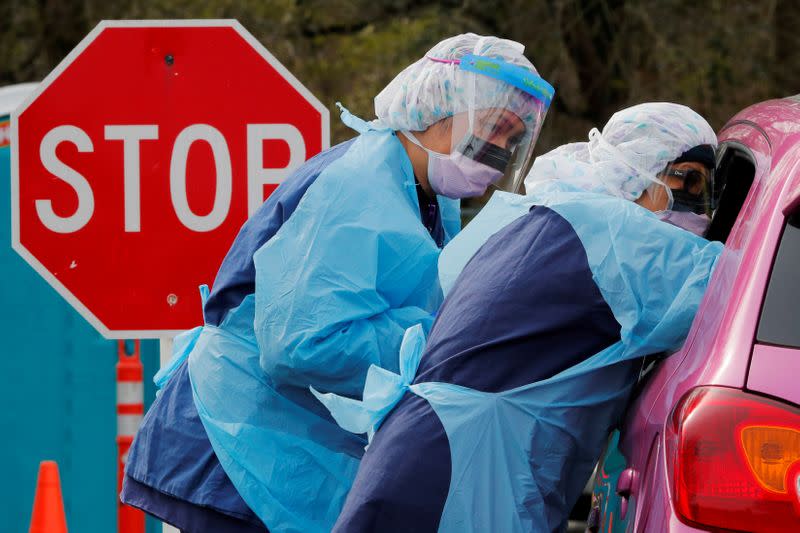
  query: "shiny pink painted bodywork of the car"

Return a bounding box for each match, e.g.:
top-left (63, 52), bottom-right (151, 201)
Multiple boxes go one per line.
top-left (599, 98), bottom-right (800, 532)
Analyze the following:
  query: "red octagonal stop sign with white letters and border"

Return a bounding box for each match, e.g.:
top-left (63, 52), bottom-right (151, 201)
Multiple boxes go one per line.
top-left (11, 21), bottom-right (329, 338)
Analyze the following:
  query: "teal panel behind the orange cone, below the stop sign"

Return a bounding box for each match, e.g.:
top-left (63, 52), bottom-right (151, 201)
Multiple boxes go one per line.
top-left (0, 117), bottom-right (160, 533)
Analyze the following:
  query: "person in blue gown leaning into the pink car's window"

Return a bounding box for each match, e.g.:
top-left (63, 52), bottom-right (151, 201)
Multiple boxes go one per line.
top-left (315, 103), bottom-right (722, 533)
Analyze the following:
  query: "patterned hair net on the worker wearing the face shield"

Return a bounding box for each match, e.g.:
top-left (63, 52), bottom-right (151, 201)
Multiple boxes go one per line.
top-left (375, 33), bottom-right (538, 131)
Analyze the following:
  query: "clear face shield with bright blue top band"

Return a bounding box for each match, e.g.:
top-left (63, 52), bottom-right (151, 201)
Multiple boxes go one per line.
top-left (422, 55), bottom-right (554, 196)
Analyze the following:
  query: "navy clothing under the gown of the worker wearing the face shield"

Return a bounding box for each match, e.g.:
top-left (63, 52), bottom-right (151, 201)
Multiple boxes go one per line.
top-left (121, 135), bottom-right (444, 532)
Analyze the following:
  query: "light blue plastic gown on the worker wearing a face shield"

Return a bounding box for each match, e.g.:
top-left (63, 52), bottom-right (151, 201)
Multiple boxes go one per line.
top-left (183, 113), bottom-right (459, 532)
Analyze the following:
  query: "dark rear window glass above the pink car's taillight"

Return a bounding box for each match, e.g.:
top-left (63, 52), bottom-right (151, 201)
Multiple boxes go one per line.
top-left (756, 213), bottom-right (800, 348)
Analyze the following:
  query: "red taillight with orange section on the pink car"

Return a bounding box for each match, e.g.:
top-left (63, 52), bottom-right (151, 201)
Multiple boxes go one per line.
top-left (665, 387), bottom-right (800, 532)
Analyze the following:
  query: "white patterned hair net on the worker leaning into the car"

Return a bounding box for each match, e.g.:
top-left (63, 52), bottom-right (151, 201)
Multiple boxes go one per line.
top-left (525, 102), bottom-right (717, 200)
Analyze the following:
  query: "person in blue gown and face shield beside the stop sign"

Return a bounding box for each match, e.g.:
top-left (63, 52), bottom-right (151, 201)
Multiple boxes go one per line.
top-left (122, 34), bottom-right (553, 533)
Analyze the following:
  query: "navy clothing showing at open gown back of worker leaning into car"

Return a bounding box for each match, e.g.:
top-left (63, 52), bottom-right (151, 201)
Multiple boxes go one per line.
top-left (335, 206), bottom-right (620, 532)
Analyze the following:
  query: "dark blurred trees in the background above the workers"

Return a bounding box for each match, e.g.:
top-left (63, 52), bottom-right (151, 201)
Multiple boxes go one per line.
top-left (0, 0), bottom-right (800, 208)
